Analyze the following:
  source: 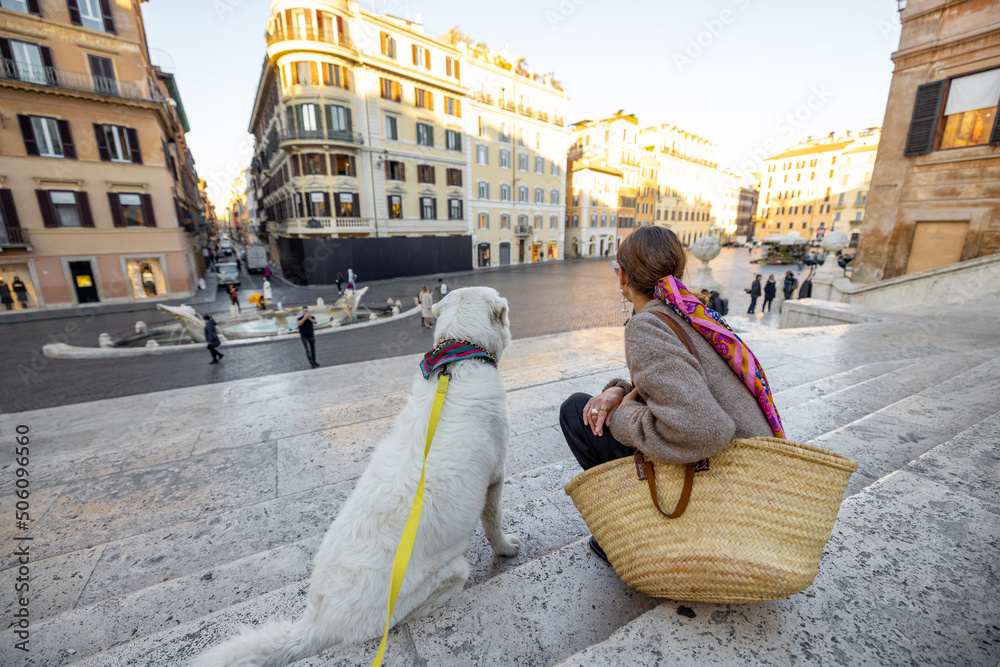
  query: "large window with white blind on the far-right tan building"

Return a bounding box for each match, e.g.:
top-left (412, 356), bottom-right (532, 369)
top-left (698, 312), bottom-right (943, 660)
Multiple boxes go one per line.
top-left (940, 68), bottom-right (1000, 148)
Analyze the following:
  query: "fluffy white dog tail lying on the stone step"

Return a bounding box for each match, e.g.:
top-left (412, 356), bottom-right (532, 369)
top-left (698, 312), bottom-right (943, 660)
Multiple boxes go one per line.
top-left (191, 620), bottom-right (326, 667)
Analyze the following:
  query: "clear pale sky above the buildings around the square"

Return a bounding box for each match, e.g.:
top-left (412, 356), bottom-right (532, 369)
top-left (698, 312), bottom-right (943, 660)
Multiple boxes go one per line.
top-left (142, 0), bottom-right (899, 207)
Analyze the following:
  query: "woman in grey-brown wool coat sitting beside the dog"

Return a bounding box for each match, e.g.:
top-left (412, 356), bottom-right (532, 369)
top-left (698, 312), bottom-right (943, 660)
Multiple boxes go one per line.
top-left (559, 227), bottom-right (784, 560)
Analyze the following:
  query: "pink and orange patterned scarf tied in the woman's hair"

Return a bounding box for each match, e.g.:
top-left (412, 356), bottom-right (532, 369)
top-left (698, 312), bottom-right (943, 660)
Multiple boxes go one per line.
top-left (653, 276), bottom-right (785, 438)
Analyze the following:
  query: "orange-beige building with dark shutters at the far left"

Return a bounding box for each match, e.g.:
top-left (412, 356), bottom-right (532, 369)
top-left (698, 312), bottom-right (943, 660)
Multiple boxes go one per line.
top-left (0, 0), bottom-right (203, 312)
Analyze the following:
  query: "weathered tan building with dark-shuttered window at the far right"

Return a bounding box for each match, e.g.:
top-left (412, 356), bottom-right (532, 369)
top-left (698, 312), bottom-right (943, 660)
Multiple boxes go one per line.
top-left (853, 0), bottom-right (1000, 283)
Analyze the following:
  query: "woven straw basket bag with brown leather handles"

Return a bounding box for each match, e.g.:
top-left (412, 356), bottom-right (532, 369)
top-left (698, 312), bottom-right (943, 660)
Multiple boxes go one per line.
top-left (566, 438), bottom-right (858, 603)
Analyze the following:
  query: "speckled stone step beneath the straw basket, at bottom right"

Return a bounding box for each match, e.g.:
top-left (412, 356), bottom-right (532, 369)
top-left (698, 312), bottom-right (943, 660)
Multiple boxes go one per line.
top-left (560, 412), bottom-right (1000, 667)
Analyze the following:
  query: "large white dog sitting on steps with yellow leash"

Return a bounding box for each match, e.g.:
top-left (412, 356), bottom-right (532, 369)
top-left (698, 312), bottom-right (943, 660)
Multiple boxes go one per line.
top-left (194, 287), bottom-right (520, 667)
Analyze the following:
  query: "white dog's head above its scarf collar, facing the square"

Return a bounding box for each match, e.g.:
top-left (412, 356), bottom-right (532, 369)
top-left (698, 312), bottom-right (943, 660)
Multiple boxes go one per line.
top-left (431, 287), bottom-right (510, 361)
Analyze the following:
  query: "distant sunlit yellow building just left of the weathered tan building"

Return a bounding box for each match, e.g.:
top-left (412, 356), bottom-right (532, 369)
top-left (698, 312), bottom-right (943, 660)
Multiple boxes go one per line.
top-left (754, 127), bottom-right (881, 246)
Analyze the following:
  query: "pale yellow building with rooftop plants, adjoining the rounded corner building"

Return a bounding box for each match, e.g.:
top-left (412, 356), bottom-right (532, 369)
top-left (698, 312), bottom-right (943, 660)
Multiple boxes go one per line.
top-left (452, 36), bottom-right (568, 267)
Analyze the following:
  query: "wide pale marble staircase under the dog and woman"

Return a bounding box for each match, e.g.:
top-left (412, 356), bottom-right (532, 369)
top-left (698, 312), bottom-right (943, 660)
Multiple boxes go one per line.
top-left (0, 301), bottom-right (1000, 666)
